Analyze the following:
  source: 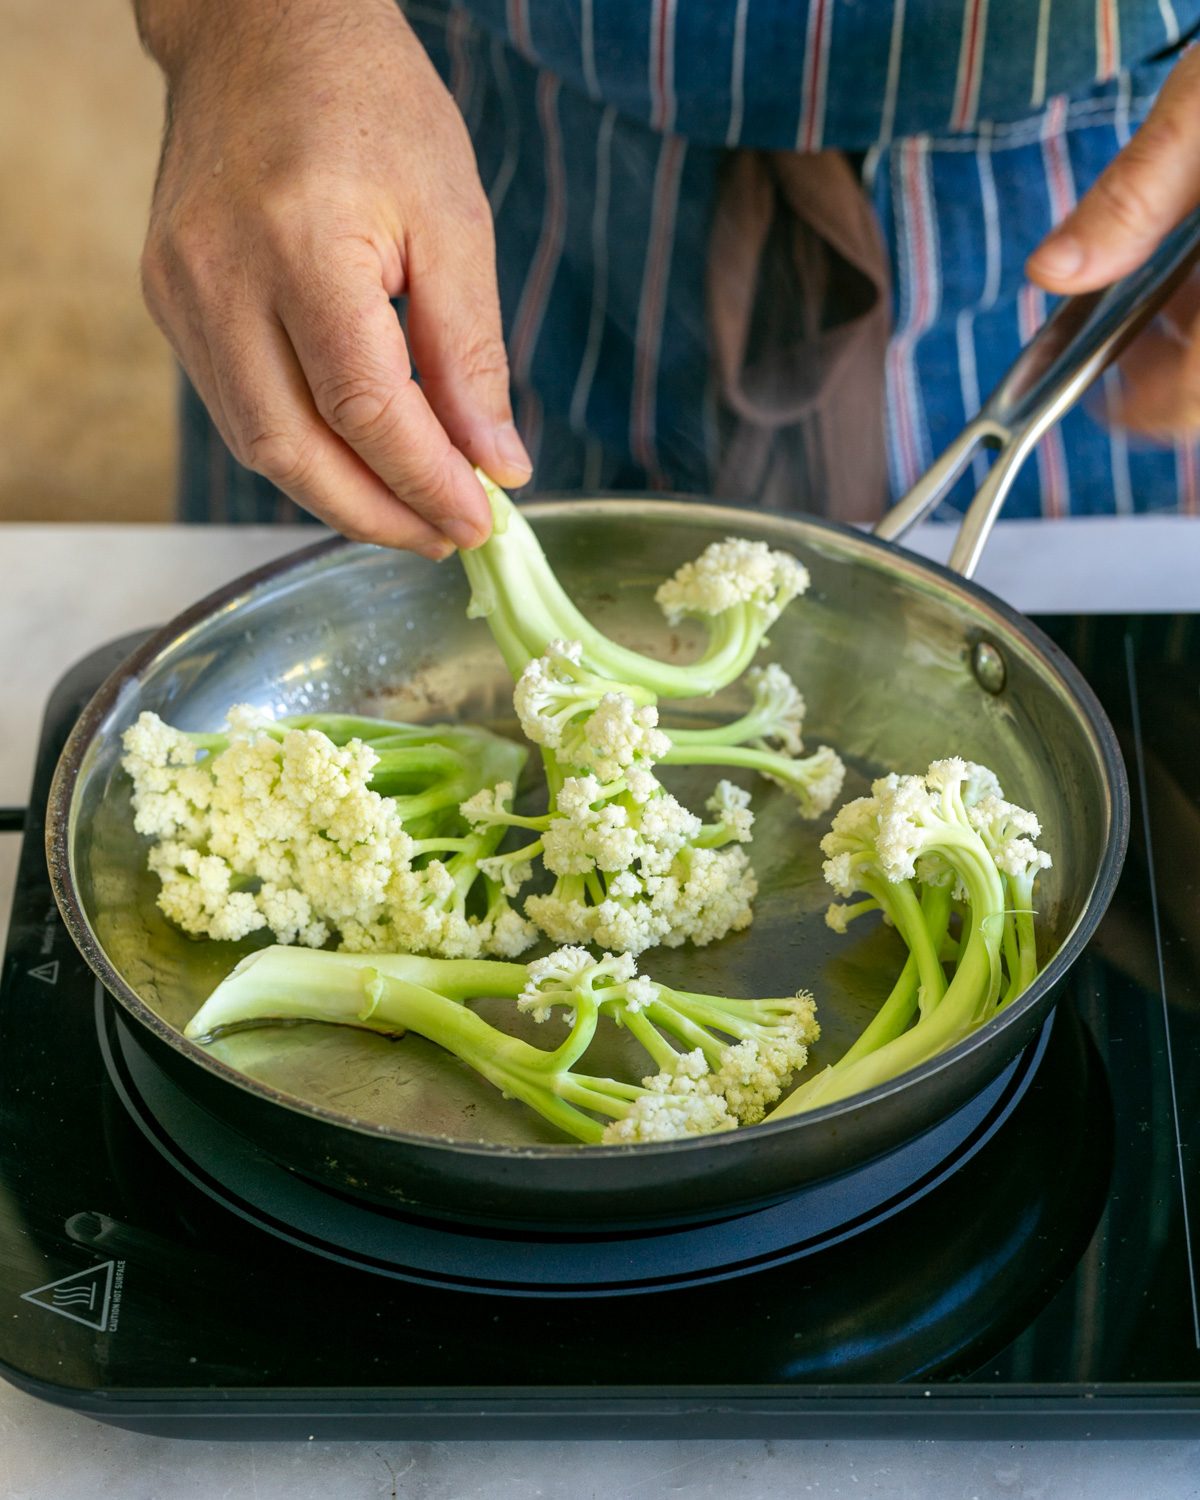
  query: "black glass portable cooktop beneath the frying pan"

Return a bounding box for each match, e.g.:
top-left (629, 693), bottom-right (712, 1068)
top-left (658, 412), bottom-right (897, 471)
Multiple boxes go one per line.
top-left (0, 617), bottom-right (1200, 1439)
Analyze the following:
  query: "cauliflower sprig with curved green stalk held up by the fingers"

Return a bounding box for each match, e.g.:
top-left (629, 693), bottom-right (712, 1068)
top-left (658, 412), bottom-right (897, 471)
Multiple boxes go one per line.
top-left (462, 476), bottom-right (845, 954)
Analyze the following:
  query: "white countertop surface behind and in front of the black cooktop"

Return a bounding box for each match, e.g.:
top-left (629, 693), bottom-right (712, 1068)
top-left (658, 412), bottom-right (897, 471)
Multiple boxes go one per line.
top-left (0, 518), bottom-right (1200, 1500)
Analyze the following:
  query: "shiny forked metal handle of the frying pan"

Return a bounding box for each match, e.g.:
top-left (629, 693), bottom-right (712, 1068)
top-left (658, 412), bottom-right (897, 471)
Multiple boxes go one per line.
top-left (875, 199), bottom-right (1200, 578)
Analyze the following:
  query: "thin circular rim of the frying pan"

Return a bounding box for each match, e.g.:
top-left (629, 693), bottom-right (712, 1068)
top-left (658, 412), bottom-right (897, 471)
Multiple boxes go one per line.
top-left (47, 494), bottom-right (1131, 1164)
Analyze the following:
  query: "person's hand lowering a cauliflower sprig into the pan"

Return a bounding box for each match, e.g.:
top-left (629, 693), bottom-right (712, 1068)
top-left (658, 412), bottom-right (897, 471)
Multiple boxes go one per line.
top-left (140, 0), bottom-right (530, 558)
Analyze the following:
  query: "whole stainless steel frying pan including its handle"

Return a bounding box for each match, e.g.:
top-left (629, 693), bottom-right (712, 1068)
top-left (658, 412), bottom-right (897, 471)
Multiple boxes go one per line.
top-left (48, 216), bottom-right (1200, 1229)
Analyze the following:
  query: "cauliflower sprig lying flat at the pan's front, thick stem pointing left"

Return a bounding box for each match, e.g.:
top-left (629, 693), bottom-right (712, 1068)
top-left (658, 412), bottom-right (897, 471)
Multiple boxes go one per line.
top-left (186, 947), bottom-right (818, 1145)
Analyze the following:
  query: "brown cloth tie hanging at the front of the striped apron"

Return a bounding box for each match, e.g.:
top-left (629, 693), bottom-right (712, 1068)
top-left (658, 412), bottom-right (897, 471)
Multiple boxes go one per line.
top-left (708, 152), bottom-right (891, 521)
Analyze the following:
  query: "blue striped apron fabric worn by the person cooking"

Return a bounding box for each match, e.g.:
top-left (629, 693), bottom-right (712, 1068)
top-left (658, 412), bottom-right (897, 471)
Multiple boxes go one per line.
top-left (183, 0), bottom-right (1200, 519)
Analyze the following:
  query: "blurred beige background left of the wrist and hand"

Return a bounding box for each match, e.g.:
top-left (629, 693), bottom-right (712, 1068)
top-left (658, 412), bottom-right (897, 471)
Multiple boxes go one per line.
top-left (0, 0), bottom-right (174, 521)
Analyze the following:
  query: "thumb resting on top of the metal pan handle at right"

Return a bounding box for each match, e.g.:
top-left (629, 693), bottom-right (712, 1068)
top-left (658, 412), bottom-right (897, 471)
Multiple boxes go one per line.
top-left (1026, 50), bottom-right (1200, 293)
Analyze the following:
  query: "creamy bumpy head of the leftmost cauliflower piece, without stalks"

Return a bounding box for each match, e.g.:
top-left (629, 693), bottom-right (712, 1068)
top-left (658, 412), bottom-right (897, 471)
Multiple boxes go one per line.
top-left (123, 707), bottom-right (534, 957)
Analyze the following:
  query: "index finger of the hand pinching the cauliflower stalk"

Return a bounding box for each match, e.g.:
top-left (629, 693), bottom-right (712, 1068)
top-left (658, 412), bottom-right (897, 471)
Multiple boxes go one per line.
top-left (278, 251), bottom-right (492, 548)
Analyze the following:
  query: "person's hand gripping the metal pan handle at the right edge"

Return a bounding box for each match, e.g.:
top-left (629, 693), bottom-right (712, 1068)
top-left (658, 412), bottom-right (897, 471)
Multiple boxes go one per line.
top-left (1026, 48), bottom-right (1200, 438)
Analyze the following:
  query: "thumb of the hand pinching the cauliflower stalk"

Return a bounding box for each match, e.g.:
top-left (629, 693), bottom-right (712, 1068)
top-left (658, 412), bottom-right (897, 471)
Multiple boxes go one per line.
top-left (408, 206), bottom-right (533, 489)
